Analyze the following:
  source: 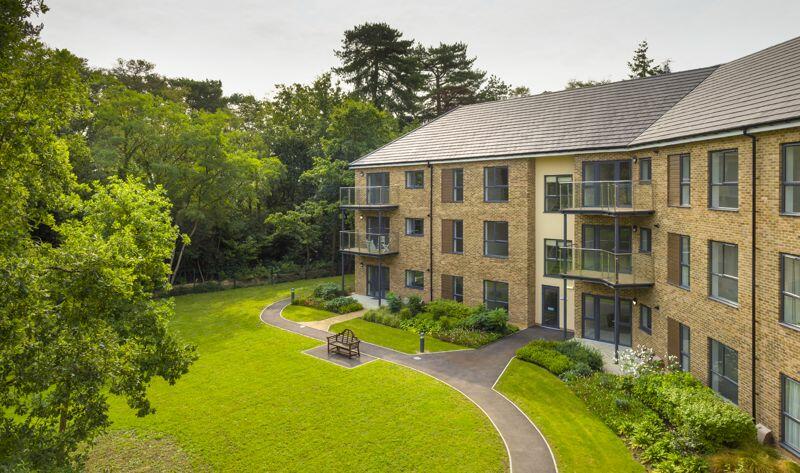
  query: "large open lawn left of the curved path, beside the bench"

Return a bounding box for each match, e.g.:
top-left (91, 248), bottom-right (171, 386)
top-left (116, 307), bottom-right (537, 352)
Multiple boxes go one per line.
top-left (89, 278), bottom-right (508, 472)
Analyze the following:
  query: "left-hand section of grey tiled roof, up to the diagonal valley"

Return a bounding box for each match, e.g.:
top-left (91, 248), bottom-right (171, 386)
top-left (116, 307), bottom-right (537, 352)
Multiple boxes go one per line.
top-left (352, 67), bottom-right (714, 166)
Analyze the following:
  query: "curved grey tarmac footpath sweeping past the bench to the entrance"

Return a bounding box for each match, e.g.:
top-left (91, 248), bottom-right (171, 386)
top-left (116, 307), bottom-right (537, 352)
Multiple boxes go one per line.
top-left (261, 299), bottom-right (561, 473)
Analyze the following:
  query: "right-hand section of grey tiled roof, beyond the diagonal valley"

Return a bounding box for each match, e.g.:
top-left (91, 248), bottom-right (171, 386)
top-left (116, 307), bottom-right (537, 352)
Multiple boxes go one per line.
top-left (632, 37), bottom-right (800, 144)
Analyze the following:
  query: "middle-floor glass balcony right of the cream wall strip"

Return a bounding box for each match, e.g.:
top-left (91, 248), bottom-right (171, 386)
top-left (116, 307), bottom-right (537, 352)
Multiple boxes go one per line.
top-left (559, 248), bottom-right (655, 288)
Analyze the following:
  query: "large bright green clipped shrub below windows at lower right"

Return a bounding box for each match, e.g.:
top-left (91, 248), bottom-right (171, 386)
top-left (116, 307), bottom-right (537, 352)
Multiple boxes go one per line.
top-left (632, 372), bottom-right (755, 451)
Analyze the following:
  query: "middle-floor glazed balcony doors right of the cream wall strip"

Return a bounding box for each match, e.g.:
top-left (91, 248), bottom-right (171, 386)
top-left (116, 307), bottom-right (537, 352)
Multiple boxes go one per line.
top-left (581, 225), bottom-right (632, 274)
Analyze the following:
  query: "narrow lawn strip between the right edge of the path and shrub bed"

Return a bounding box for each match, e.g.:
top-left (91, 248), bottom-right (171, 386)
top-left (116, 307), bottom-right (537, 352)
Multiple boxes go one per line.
top-left (497, 360), bottom-right (645, 473)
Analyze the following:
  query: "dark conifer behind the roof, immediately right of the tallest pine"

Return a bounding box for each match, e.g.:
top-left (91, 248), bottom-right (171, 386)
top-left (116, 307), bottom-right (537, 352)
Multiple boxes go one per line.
top-left (418, 43), bottom-right (486, 117)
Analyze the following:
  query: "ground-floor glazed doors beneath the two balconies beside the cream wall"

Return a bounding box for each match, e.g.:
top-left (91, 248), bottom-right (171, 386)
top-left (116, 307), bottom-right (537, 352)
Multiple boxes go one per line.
top-left (583, 294), bottom-right (633, 347)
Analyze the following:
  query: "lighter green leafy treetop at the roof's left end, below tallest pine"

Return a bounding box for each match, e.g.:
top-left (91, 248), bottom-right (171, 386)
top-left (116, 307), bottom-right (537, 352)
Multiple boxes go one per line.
top-left (321, 99), bottom-right (397, 162)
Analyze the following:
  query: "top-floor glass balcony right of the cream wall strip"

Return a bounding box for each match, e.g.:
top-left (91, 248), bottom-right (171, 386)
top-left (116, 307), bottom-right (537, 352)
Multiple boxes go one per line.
top-left (559, 181), bottom-right (654, 215)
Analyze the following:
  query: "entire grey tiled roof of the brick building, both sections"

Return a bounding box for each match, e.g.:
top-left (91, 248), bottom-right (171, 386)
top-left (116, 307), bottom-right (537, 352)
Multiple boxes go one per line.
top-left (352, 38), bottom-right (800, 167)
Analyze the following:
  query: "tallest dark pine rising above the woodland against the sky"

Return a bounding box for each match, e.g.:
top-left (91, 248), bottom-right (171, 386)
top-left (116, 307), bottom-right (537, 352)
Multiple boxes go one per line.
top-left (334, 23), bottom-right (423, 119)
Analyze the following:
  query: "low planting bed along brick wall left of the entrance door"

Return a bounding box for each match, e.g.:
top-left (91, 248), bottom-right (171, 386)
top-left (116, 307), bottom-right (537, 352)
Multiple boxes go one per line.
top-left (363, 293), bottom-right (518, 348)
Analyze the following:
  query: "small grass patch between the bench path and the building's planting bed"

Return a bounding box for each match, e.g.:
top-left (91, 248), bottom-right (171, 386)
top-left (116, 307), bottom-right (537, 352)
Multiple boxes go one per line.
top-left (330, 318), bottom-right (466, 353)
